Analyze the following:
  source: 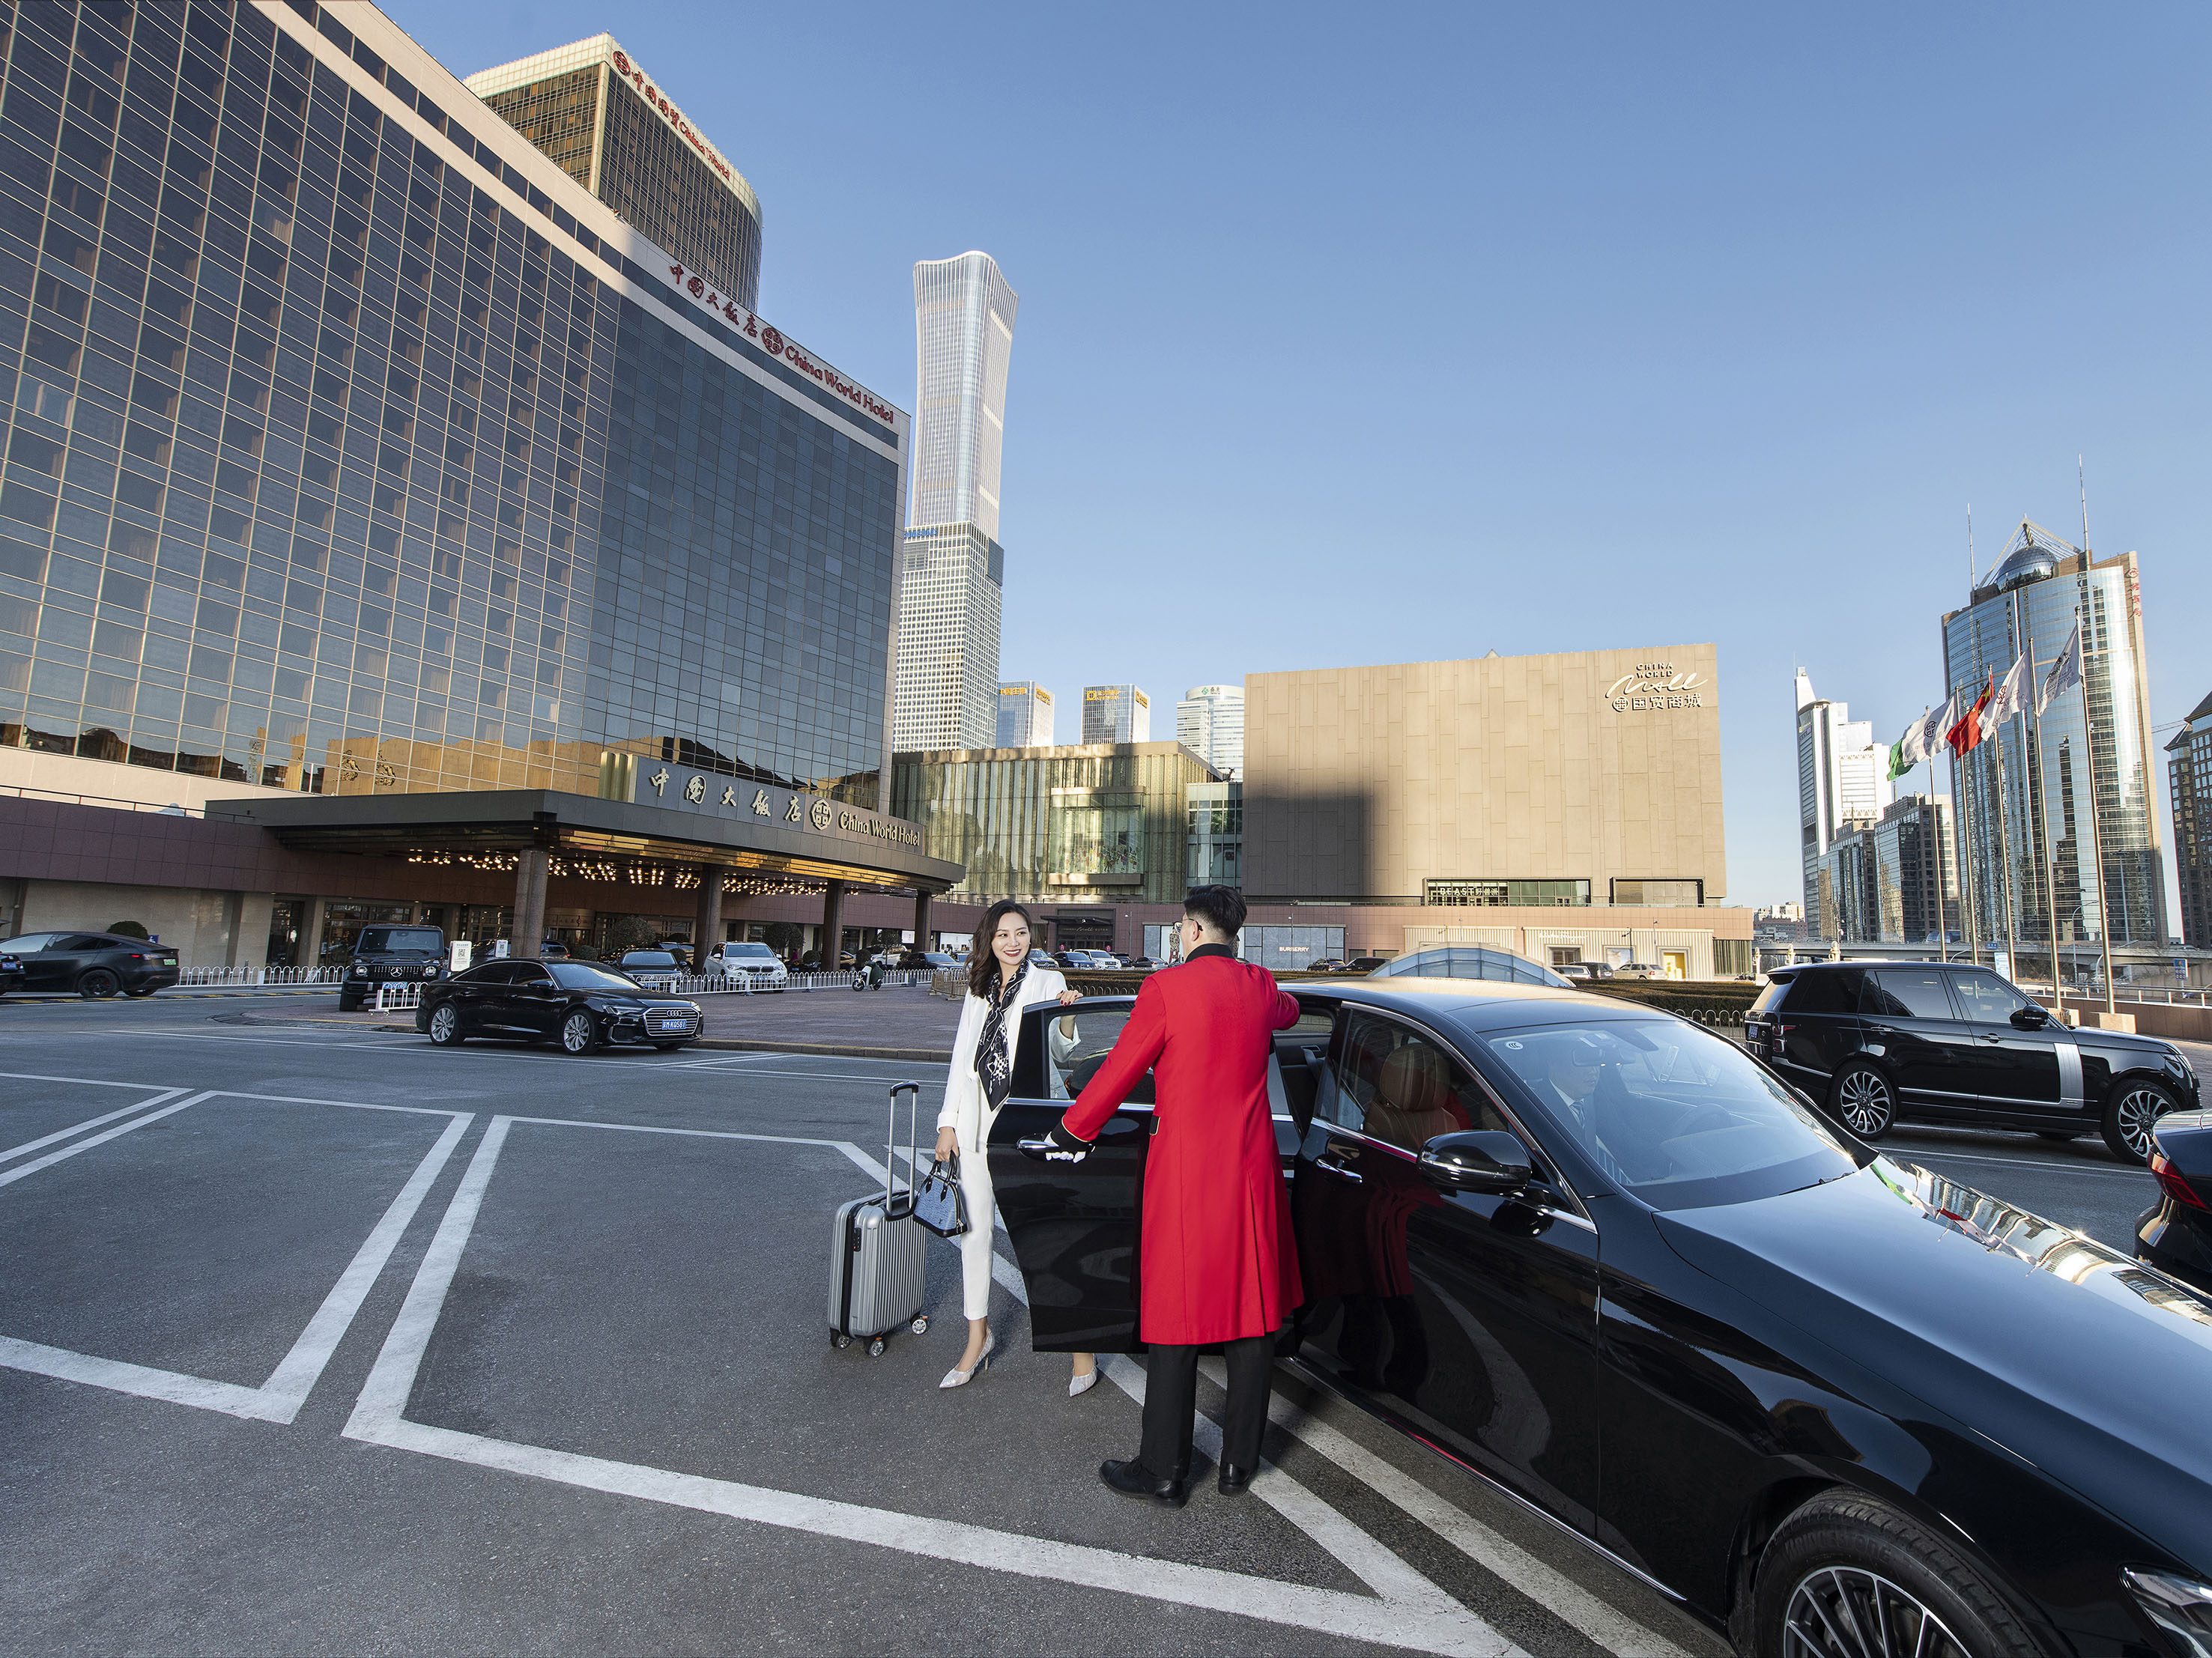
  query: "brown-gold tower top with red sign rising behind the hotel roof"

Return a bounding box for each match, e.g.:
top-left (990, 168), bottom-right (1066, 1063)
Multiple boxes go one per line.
top-left (464, 35), bottom-right (761, 312)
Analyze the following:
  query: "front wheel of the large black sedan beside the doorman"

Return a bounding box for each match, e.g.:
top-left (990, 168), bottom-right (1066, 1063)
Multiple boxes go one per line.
top-left (1748, 1492), bottom-right (2042, 1658)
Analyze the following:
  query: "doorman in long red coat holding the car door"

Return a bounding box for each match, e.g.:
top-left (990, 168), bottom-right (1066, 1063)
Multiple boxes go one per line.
top-left (1053, 887), bottom-right (1303, 1507)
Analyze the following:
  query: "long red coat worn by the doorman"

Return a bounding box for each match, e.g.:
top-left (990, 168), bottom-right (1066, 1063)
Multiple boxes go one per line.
top-left (1061, 950), bottom-right (1300, 1346)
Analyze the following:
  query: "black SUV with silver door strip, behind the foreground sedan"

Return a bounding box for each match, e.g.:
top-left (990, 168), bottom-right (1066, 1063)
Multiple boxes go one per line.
top-left (1743, 962), bottom-right (2196, 1163)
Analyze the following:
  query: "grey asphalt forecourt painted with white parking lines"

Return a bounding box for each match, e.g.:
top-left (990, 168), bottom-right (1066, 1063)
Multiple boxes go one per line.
top-left (0, 997), bottom-right (2176, 1658)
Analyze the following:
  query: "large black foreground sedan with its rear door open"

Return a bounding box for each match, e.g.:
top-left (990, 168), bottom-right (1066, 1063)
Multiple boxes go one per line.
top-left (989, 977), bottom-right (2212, 1658)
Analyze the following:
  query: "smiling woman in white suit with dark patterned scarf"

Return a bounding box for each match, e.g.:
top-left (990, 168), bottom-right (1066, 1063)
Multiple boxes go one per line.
top-left (936, 902), bottom-right (1097, 1397)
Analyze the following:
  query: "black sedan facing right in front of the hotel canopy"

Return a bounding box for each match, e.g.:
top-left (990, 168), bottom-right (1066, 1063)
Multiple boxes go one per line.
top-left (416, 957), bottom-right (699, 1054)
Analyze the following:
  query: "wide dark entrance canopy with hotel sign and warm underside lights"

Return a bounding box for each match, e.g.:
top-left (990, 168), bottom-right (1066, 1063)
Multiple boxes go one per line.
top-left (208, 776), bottom-right (963, 896)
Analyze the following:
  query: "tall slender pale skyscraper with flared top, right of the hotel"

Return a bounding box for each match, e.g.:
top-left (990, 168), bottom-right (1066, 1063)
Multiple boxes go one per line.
top-left (891, 252), bottom-right (1019, 750)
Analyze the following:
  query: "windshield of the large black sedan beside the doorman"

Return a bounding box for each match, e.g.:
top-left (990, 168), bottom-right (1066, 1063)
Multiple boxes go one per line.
top-left (1482, 1019), bottom-right (1858, 1209)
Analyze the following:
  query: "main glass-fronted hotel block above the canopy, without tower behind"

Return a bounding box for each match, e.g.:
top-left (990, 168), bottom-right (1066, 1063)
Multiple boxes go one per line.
top-left (0, 0), bottom-right (902, 805)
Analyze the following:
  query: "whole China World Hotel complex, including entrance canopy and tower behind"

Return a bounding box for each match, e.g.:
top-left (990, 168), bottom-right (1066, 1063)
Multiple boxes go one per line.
top-left (0, 0), bottom-right (958, 964)
